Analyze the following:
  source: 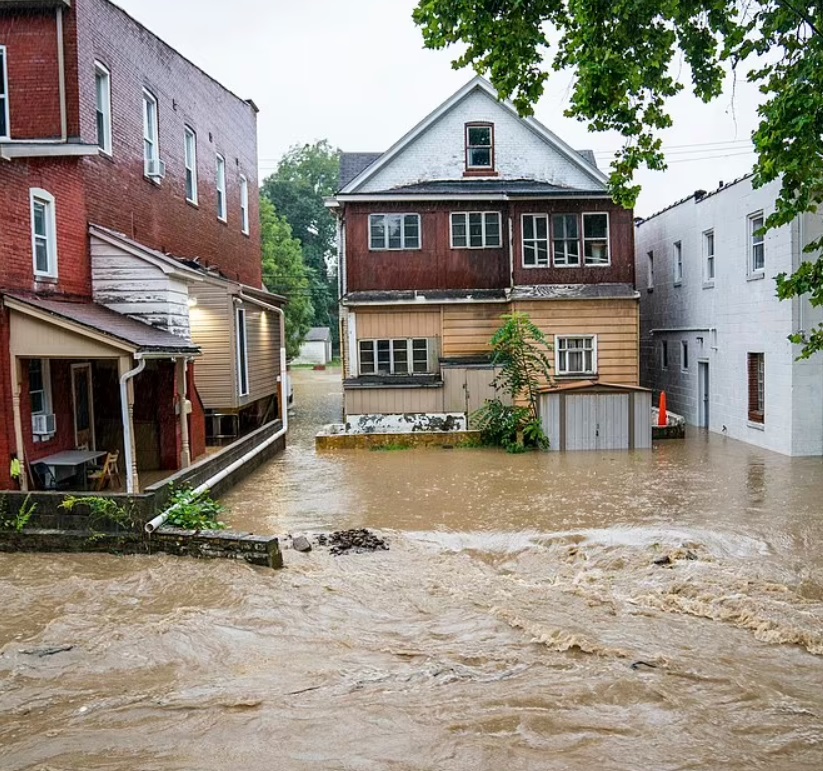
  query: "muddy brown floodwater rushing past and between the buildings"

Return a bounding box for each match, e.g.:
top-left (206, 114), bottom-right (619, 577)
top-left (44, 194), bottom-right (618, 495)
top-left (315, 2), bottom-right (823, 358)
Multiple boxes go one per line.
top-left (0, 370), bottom-right (823, 771)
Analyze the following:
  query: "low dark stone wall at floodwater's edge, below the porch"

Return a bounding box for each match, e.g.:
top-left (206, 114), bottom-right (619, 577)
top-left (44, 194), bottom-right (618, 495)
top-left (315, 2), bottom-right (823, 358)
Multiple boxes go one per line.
top-left (0, 527), bottom-right (283, 568)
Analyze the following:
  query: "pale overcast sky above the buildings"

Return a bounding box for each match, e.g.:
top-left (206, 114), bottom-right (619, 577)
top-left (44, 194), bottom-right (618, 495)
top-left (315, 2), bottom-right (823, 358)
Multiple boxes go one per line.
top-left (115, 0), bottom-right (759, 216)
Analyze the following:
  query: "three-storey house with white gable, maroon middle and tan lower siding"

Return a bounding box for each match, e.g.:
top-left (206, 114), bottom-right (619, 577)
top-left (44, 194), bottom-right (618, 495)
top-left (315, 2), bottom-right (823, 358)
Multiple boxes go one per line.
top-left (329, 77), bottom-right (639, 444)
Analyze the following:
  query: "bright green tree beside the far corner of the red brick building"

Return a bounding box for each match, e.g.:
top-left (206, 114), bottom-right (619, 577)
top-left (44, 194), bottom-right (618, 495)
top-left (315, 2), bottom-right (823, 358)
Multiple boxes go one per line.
top-left (260, 198), bottom-right (314, 359)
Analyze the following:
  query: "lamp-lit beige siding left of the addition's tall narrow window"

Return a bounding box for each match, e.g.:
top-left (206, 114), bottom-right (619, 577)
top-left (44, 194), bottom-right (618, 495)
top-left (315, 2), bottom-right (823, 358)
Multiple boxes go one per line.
top-left (190, 282), bottom-right (237, 410)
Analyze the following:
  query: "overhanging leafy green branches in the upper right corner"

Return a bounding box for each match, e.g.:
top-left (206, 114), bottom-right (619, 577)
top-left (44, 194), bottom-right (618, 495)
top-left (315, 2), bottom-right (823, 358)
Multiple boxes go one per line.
top-left (414, 0), bottom-right (823, 357)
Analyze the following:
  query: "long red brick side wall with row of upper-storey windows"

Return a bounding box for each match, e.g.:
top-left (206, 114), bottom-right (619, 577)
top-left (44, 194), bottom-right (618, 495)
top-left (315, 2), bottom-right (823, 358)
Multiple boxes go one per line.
top-left (75, 0), bottom-right (261, 286)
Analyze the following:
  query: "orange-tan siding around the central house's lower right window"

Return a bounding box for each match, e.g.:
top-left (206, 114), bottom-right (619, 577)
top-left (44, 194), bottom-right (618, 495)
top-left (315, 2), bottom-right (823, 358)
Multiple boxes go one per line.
top-left (514, 300), bottom-right (640, 385)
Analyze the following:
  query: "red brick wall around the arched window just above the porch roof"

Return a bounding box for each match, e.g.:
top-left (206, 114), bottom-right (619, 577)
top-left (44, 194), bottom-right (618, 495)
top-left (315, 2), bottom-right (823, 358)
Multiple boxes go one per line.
top-left (0, 158), bottom-right (91, 297)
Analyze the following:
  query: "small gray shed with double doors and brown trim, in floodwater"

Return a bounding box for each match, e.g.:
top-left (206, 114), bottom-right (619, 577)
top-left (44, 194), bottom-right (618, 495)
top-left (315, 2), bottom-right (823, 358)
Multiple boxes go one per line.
top-left (540, 380), bottom-right (652, 452)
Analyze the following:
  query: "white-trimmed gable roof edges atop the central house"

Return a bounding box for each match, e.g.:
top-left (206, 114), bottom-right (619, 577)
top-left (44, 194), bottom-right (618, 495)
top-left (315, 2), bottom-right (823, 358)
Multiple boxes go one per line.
top-left (340, 75), bottom-right (608, 195)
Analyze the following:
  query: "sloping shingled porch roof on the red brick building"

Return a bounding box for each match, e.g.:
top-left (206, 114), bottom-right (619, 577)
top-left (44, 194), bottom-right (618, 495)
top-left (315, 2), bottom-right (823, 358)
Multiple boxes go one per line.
top-left (4, 293), bottom-right (200, 356)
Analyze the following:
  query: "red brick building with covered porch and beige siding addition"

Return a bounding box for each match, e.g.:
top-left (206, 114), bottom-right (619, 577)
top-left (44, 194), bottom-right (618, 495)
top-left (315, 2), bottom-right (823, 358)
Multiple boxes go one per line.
top-left (0, 0), bottom-right (282, 489)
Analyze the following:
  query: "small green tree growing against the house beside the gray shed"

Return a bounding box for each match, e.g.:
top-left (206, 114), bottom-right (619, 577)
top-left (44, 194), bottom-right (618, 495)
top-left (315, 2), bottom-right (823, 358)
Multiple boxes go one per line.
top-left (473, 312), bottom-right (551, 452)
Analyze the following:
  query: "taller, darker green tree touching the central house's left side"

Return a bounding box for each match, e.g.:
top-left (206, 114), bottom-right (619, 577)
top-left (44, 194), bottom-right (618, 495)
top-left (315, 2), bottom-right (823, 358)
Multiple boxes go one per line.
top-left (261, 140), bottom-right (340, 342)
